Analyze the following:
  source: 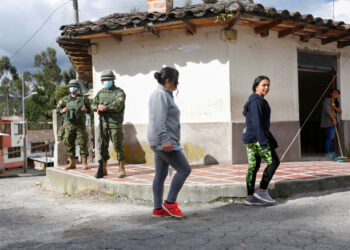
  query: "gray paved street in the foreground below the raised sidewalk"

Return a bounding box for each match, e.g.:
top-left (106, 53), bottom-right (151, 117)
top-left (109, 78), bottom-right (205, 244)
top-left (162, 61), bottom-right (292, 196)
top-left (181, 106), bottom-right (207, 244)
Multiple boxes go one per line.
top-left (0, 177), bottom-right (350, 250)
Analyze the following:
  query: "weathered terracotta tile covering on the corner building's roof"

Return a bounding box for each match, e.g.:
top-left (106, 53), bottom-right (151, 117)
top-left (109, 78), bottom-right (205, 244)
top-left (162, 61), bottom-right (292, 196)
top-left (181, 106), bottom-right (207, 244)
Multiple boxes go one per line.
top-left (61, 1), bottom-right (350, 37)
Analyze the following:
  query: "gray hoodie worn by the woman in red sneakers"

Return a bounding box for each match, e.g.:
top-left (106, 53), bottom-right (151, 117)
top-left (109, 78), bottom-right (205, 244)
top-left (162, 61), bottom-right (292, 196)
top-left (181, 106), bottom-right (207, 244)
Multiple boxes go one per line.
top-left (148, 84), bottom-right (180, 146)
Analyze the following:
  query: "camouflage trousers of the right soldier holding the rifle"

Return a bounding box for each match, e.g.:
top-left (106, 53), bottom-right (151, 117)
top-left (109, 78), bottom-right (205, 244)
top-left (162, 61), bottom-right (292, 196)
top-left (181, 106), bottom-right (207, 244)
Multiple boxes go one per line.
top-left (98, 123), bottom-right (125, 161)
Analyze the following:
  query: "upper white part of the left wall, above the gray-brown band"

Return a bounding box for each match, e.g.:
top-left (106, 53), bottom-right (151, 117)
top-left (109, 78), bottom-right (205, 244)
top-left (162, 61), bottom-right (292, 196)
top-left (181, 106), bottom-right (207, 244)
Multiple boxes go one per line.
top-left (93, 27), bottom-right (230, 124)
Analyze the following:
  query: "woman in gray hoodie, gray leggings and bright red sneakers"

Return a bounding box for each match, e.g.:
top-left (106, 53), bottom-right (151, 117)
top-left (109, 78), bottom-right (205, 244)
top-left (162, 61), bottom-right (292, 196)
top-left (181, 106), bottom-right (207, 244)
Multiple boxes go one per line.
top-left (148, 67), bottom-right (191, 217)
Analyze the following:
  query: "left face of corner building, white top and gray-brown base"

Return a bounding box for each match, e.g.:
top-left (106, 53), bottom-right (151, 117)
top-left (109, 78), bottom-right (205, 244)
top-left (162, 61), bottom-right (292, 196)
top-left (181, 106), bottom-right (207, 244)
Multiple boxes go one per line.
top-left (93, 27), bottom-right (231, 164)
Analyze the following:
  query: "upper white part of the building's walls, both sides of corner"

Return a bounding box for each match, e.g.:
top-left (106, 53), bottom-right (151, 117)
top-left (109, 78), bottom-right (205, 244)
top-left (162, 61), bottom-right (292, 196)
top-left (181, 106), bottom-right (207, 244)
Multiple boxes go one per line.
top-left (93, 23), bottom-right (350, 124)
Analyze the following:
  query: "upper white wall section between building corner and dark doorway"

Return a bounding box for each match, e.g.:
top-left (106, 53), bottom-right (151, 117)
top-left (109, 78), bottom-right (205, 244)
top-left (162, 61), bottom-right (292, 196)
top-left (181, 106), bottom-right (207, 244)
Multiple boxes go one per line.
top-left (229, 26), bottom-right (299, 122)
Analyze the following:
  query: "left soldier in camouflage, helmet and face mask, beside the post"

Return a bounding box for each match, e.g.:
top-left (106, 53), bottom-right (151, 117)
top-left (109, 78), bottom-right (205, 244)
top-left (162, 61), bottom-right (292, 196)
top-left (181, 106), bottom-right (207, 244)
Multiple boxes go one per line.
top-left (56, 80), bottom-right (90, 170)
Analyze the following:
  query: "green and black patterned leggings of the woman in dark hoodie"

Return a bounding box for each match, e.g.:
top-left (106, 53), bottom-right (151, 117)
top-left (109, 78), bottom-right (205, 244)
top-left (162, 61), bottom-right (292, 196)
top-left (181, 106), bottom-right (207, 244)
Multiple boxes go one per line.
top-left (245, 142), bottom-right (280, 195)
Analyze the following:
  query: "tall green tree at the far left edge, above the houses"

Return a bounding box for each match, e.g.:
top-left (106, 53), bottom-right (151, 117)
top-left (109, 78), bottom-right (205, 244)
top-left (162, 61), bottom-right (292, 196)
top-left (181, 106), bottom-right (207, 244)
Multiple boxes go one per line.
top-left (0, 56), bottom-right (19, 116)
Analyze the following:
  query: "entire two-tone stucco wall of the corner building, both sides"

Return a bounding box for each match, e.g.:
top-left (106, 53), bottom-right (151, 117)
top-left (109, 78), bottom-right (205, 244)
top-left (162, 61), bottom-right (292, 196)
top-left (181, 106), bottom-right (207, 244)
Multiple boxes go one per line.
top-left (92, 22), bottom-right (350, 163)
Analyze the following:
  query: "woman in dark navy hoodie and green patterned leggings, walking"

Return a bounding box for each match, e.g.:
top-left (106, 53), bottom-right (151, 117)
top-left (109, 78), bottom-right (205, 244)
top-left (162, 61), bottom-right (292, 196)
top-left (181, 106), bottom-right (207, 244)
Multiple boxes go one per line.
top-left (242, 76), bottom-right (280, 205)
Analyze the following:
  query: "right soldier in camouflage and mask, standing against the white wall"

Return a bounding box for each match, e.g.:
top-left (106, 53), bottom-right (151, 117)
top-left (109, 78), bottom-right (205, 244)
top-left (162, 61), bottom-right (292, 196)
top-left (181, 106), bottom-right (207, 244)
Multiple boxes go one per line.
top-left (92, 70), bottom-right (126, 178)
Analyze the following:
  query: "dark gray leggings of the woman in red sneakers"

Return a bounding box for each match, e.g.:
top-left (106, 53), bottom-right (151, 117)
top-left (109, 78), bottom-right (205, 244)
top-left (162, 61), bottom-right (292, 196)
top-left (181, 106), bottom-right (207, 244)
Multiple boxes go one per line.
top-left (151, 147), bottom-right (191, 209)
